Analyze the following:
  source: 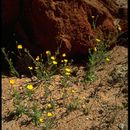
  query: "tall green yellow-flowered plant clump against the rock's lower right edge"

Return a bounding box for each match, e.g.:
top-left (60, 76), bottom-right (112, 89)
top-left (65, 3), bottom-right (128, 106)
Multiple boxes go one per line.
top-left (84, 39), bottom-right (109, 82)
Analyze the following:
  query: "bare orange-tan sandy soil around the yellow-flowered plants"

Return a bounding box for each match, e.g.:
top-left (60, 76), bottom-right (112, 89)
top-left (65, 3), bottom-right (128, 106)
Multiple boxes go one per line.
top-left (2, 46), bottom-right (128, 130)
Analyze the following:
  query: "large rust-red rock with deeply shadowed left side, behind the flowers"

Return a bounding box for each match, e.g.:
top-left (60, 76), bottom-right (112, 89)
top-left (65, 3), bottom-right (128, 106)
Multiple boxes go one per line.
top-left (2, 0), bottom-right (120, 55)
